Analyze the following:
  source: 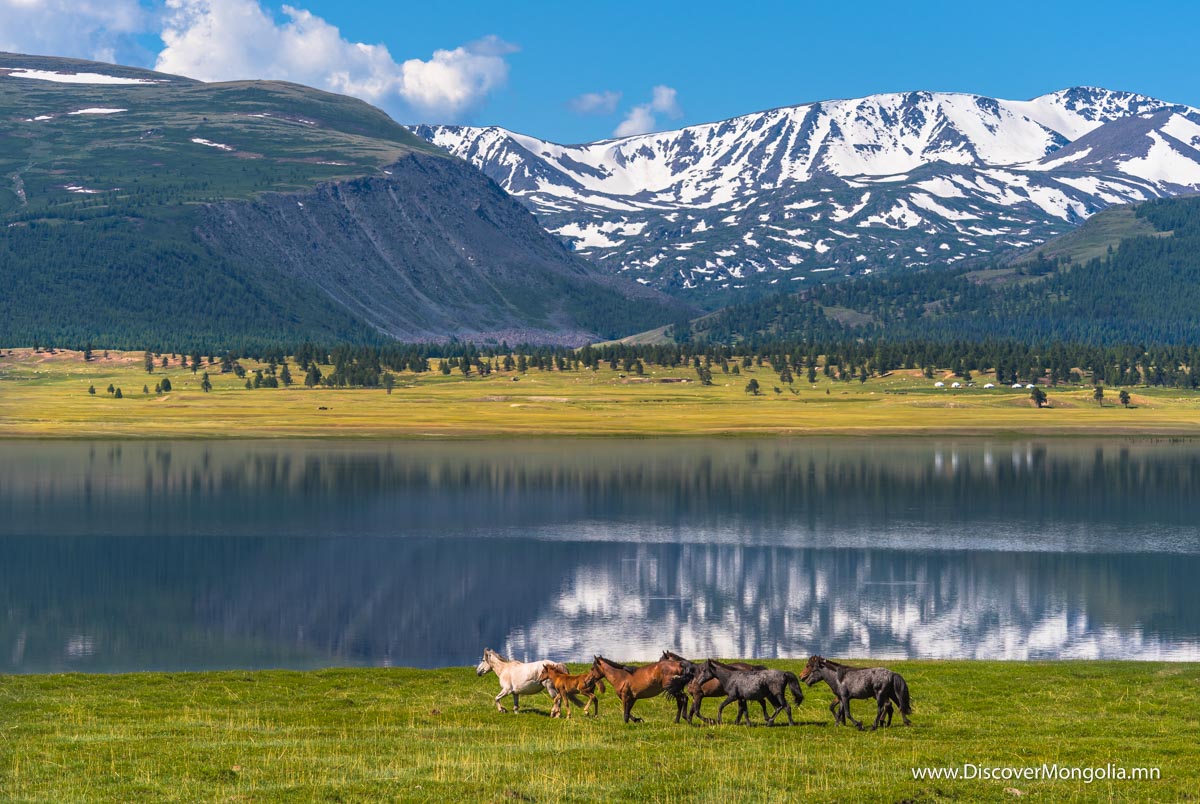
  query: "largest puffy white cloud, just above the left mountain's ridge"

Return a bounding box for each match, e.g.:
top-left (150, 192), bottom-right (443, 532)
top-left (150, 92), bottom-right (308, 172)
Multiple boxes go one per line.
top-left (156, 0), bottom-right (516, 122)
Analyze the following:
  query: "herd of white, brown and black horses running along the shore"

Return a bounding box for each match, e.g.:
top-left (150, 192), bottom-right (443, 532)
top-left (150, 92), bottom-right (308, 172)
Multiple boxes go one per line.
top-left (475, 648), bottom-right (912, 730)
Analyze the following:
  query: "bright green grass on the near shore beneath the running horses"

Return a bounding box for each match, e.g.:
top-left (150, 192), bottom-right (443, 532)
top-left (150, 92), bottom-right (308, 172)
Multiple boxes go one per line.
top-left (0, 661), bottom-right (1200, 802)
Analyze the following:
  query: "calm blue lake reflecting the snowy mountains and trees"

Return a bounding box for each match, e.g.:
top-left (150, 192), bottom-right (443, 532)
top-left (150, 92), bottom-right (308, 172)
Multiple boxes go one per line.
top-left (0, 439), bottom-right (1200, 673)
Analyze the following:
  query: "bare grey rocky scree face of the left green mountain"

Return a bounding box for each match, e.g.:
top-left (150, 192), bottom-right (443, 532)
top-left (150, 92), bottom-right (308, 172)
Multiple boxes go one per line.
top-left (197, 154), bottom-right (680, 344)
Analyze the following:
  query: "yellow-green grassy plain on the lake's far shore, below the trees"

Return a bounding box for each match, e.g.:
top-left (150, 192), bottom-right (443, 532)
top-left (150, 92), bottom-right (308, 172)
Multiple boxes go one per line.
top-left (0, 349), bottom-right (1200, 438)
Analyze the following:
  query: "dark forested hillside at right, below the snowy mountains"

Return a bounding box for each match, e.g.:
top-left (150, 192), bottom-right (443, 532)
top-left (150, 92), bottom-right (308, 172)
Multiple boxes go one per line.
top-left (676, 196), bottom-right (1200, 344)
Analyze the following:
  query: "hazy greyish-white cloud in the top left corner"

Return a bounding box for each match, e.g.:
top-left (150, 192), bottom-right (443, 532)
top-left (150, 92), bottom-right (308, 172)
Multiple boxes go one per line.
top-left (0, 0), bottom-right (150, 61)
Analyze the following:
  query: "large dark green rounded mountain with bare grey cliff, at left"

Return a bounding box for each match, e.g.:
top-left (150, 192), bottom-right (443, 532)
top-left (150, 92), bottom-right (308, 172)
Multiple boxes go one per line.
top-left (0, 54), bottom-right (680, 348)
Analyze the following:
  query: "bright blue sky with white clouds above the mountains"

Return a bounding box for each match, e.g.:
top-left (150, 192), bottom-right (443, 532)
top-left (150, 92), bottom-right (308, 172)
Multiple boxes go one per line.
top-left (0, 0), bottom-right (1200, 142)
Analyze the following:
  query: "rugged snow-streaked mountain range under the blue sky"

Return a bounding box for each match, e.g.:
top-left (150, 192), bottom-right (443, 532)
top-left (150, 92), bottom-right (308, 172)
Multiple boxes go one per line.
top-left (414, 88), bottom-right (1200, 305)
